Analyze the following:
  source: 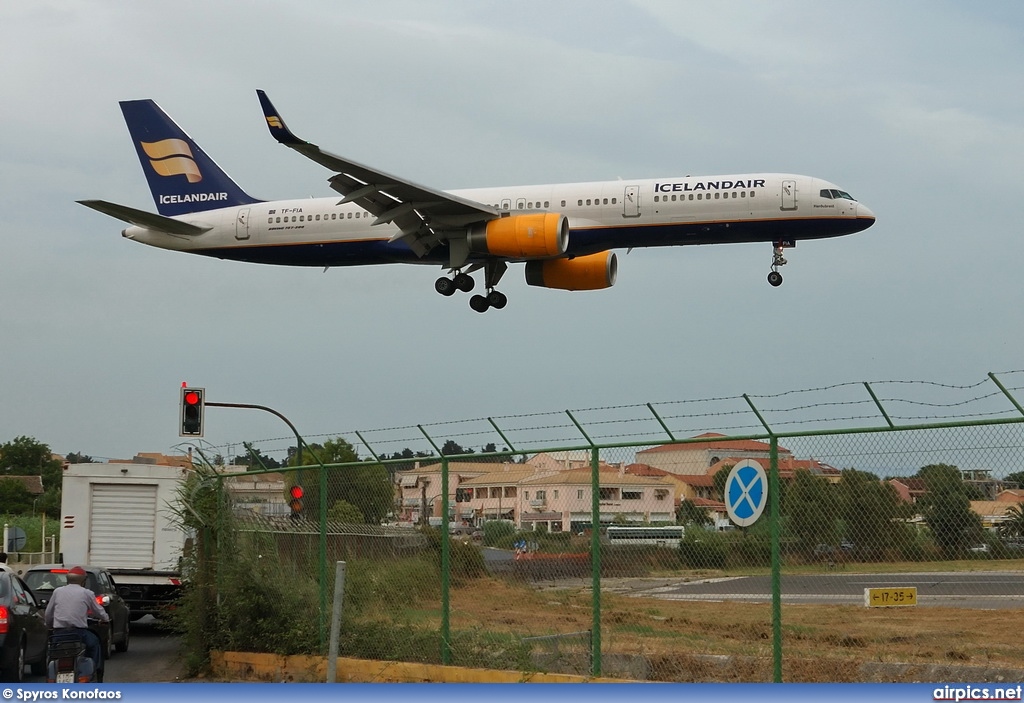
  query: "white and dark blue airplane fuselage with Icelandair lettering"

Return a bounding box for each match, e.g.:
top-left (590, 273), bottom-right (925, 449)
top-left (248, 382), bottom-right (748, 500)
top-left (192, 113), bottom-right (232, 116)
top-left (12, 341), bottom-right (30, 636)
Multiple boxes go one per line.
top-left (123, 173), bottom-right (874, 266)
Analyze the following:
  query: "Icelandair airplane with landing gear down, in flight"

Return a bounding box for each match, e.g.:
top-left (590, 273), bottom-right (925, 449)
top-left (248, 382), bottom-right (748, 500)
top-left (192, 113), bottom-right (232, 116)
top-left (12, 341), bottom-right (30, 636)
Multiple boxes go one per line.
top-left (78, 90), bottom-right (874, 312)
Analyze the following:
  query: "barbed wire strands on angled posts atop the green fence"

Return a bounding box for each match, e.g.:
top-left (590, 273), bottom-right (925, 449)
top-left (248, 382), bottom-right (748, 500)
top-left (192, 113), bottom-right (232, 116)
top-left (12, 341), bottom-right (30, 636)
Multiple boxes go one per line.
top-left (197, 369), bottom-right (1024, 458)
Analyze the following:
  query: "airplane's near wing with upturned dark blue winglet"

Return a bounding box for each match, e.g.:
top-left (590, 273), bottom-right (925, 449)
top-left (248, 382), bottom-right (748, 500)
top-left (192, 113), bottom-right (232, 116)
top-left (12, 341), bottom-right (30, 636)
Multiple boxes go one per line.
top-left (256, 90), bottom-right (501, 259)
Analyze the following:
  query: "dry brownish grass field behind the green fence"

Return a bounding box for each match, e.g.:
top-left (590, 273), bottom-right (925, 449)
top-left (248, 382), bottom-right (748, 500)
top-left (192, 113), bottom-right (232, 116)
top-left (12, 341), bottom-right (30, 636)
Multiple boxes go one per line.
top-left (432, 562), bottom-right (1024, 682)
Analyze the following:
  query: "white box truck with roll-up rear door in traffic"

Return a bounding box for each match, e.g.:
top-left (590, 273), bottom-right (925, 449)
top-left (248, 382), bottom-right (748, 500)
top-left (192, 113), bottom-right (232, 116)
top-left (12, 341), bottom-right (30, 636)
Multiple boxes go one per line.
top-left (60, 464), bottom-right (189, 619)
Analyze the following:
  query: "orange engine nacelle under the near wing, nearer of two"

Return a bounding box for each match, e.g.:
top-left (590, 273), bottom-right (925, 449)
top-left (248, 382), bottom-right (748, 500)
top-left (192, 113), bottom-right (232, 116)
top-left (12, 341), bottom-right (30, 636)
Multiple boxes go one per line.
top-left (467, 213), bottom-right (569, 259)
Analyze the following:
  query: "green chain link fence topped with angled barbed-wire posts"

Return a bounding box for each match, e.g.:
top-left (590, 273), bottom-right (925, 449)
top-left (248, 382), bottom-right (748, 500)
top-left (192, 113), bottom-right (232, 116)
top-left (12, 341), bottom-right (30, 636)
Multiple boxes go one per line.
top-left (182, 376), bottom-right (1024, 682)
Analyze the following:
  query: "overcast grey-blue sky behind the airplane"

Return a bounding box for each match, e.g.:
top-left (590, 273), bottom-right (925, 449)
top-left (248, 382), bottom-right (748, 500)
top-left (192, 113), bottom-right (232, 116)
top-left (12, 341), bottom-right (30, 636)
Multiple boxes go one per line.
top-left (0, 0), bottom-right (1024, 464)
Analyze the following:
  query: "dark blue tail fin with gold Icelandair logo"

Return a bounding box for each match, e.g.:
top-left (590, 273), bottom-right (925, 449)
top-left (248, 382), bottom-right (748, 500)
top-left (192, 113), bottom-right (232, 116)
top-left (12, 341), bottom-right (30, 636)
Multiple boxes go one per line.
top-left (121, 100), bottom-right (260, 217)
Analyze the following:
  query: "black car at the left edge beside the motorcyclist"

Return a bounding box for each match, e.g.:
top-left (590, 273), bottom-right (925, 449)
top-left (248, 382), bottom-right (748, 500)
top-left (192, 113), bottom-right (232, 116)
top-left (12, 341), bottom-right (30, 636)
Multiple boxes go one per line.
top-left (0, 568), bottom-right (47, 683)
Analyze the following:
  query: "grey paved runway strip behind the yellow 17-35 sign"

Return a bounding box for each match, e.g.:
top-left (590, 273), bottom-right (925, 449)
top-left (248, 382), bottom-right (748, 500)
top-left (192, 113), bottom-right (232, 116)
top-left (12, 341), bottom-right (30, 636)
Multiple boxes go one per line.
top-left (603, 571), bottom-right (1024, 609)
